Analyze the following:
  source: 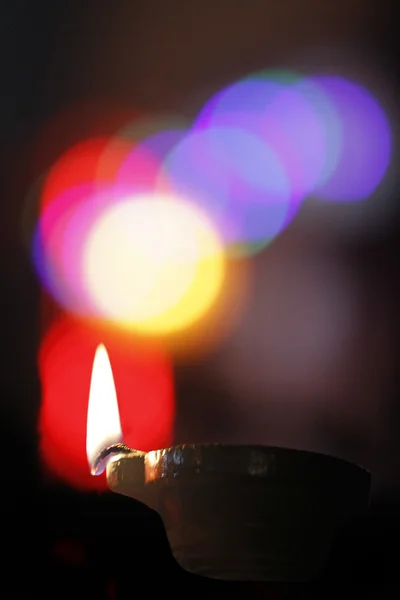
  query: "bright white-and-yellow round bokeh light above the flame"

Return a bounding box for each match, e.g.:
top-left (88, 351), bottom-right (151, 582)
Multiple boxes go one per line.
top-left (83, 195), bottom-right (225, 335)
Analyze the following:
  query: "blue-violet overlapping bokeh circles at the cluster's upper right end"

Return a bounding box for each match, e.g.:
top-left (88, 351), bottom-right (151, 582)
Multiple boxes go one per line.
top-left (194, 71), bottom-right (391, 210)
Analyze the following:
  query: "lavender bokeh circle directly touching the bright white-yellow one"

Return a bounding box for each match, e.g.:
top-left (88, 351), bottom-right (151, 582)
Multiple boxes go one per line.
top-left (163, 126), bottom-right (291, 254)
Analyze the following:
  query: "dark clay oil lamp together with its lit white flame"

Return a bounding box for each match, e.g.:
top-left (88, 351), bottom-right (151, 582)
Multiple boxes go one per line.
top-left (87, 345), bottom-right (370, 582)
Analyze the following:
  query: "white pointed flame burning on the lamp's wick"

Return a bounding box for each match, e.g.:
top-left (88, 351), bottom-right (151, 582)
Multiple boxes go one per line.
top-left (86, 344), bottom-right (122, 474)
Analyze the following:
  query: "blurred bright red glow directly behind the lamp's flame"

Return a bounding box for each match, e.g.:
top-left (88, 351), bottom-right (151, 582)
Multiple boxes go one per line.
top-left (39, 317), bottom-right (175, 490)
